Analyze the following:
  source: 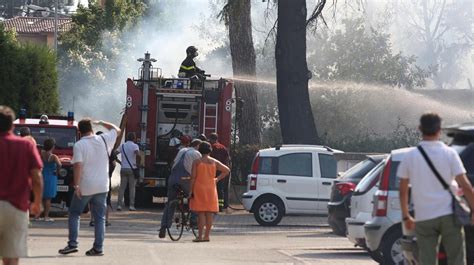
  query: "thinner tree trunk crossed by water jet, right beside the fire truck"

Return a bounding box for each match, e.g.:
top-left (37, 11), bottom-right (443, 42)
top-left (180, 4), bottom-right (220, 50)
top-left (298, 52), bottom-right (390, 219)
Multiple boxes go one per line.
top-left (228, 0), bottom-right (261, 144)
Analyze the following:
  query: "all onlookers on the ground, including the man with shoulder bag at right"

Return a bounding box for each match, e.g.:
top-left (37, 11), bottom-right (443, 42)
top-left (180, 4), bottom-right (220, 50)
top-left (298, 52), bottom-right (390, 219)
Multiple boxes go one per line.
top-left (0, 103), bottom-right (474, 265)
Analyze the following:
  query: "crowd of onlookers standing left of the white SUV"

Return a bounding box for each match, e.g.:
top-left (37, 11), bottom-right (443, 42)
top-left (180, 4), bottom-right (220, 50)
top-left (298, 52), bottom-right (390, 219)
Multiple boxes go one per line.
top-left (0, 106), bottom-right (230, 265)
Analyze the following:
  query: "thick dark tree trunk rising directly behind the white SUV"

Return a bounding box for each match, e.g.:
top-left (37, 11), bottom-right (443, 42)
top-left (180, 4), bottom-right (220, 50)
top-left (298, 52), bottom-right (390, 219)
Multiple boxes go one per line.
top-left (275, 0), bottom-right (319, 144)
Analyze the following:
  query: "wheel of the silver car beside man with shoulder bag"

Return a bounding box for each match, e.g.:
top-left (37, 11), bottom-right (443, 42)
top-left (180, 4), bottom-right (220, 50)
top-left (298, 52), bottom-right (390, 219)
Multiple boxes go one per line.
top-left (380, 228), bottom-right (407, 265)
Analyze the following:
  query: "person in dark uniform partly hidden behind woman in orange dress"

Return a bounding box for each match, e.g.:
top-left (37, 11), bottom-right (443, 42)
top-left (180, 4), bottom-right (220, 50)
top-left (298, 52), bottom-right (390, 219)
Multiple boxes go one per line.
top-left (209, 133), bottom-right (230, 212)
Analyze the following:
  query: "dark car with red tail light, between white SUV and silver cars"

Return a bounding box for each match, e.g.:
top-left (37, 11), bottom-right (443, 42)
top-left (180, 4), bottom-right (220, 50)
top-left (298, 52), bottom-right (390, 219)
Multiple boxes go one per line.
top-left (328, 155), bottom-right (387, 236)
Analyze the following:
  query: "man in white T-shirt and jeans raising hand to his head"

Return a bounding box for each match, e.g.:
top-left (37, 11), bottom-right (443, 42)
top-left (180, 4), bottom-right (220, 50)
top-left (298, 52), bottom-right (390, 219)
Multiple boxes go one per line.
top-left (59, 119), bottom-right (120, 256)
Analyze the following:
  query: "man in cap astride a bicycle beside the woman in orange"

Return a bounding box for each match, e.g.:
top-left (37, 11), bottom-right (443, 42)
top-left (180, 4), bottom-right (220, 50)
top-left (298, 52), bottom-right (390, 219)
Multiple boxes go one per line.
top-left (159, 139), bottom-right (201, 238)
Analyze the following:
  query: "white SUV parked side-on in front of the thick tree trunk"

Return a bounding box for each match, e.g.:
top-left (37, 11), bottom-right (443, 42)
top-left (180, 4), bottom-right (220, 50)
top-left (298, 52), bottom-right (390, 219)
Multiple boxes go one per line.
top-left (242, 145), bottom-right (342, 226)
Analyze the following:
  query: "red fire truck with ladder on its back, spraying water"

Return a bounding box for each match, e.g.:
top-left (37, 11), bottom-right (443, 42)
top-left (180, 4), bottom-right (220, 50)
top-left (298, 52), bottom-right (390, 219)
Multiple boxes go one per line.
top-left (125, 53), bottom-right (233, 206)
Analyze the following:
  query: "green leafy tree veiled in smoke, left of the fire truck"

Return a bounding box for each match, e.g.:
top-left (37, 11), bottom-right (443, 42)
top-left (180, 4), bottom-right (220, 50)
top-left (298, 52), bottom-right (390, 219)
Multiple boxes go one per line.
top-left (58, 0), bottom-right (145, 111)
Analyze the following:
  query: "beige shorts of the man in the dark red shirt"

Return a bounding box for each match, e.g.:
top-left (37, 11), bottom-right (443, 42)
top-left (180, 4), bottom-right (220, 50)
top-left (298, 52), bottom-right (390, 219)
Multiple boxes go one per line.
top-left (0, 201), bottom-right (28, 258)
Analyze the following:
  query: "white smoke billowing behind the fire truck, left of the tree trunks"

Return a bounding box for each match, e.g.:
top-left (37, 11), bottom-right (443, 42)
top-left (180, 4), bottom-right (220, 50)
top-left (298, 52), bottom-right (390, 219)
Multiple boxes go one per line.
top-left (65, 0), bottom-right (225, 123)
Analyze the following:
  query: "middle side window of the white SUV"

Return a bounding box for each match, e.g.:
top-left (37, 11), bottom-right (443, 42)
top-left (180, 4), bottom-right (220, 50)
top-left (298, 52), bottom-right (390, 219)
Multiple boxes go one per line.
top-left (278, 153), bottom-right (313, 177)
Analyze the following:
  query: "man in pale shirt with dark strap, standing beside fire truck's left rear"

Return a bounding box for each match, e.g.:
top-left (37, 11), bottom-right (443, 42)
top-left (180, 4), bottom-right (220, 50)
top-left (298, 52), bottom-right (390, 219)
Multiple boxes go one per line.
top-left (117, 132), bottom-right (141, 211)
